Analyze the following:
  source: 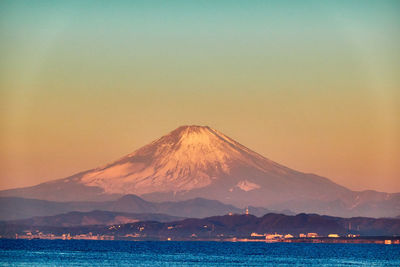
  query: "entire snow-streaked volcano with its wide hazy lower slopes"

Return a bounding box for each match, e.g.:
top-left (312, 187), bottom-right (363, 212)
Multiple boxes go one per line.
top-left (0, 126), bottom-right (400, 217)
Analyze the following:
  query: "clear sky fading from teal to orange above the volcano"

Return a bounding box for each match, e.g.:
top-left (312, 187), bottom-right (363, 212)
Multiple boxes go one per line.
top-left (0, 0), bottom-right (400, 192)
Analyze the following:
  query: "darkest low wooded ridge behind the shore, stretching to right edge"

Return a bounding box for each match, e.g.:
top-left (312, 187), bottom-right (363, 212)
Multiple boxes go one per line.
top-left (95, 213), bottom-right (400, 237)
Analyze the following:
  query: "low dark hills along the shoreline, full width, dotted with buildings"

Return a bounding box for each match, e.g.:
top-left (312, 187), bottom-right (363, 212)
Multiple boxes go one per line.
top-left (0, 213), bottom-right (400, 240)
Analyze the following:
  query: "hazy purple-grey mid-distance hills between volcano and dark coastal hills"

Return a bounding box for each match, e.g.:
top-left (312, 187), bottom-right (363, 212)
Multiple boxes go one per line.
top-left (0, 195), bottom-right (282, 221)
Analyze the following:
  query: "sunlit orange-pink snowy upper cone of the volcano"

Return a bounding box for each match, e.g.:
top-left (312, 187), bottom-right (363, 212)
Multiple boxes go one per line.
top-left (80, 126), bottom-right (280, 195)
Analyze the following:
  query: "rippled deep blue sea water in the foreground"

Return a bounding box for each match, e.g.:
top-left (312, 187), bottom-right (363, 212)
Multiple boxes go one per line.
top-left (0, 239), bottom-right (400, 267)
